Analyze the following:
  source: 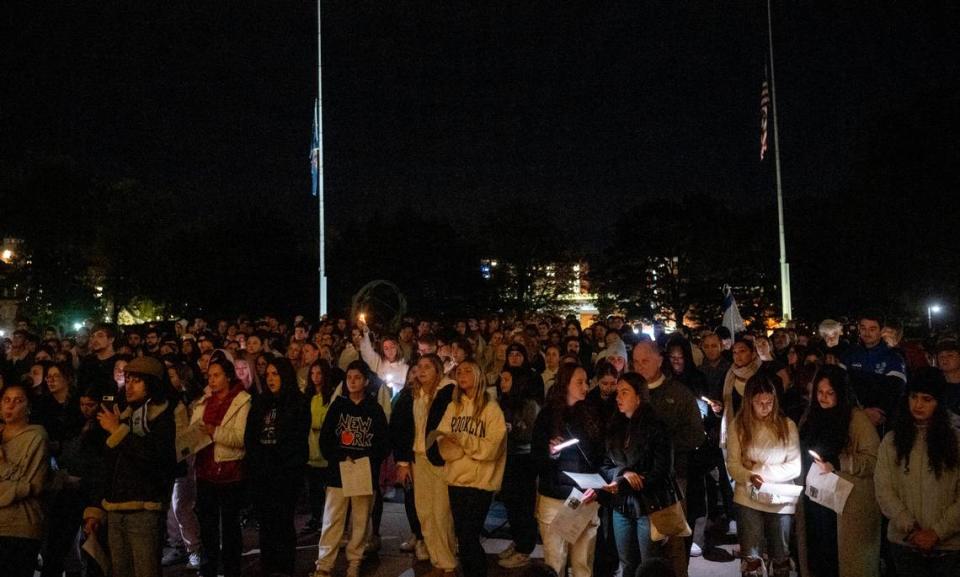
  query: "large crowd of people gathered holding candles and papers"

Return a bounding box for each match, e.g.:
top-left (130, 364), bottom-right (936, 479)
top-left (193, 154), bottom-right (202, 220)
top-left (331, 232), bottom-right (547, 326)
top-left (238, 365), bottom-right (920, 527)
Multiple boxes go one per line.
top-left (0, 313), bottom-right (960, 577)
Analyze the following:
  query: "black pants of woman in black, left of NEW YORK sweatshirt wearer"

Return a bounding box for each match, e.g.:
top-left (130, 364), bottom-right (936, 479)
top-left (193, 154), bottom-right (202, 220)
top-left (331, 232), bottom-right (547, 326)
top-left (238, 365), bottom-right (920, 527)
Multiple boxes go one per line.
top-left (254, 473), bottom-right (303, 575)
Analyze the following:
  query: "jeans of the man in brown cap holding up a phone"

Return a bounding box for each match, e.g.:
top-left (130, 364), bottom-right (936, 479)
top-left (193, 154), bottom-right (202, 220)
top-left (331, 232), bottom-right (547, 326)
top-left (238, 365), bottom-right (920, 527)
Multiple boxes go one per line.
top-left (107, 511), bottom-right (167, 577)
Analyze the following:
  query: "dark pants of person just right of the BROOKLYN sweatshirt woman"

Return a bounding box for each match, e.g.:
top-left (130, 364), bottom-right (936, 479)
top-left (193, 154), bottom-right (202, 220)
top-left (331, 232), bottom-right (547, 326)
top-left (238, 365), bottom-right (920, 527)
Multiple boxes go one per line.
top-left (500, 453), bottom-right (537, 555)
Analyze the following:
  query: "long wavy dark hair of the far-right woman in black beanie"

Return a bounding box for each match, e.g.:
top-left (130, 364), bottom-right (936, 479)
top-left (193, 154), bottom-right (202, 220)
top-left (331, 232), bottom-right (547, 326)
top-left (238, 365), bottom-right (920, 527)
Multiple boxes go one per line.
top-left (893, 367), bottom-right (960, 479)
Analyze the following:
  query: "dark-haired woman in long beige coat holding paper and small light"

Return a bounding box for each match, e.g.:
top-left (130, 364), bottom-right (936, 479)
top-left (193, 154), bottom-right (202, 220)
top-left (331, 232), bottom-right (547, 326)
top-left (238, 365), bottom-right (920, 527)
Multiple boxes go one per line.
top-left (800, 366), bottom-right (880, 577)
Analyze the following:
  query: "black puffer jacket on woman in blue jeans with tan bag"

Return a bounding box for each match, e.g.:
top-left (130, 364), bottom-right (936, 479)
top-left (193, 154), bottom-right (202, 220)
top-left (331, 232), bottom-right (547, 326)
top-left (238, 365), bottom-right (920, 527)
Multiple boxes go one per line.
top-left (602, 410), bottom-right (673, 519)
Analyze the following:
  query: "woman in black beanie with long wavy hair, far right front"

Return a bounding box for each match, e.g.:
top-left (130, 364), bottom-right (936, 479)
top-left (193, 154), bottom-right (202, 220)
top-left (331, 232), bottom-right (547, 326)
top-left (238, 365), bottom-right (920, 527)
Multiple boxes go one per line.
top-left (874, 368), bottom-right (960, 576)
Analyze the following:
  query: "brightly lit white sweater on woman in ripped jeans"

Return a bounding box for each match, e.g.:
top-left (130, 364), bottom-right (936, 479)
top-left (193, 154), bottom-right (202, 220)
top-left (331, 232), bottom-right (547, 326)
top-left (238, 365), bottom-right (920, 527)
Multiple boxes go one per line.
top-left (727, 418), bottom-right (801, 514)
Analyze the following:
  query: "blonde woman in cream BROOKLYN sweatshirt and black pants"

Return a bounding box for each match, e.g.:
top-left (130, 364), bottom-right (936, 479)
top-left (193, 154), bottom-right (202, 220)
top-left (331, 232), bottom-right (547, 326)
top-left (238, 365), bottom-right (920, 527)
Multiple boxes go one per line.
top-left (436, 361), bottom-right (507, 577)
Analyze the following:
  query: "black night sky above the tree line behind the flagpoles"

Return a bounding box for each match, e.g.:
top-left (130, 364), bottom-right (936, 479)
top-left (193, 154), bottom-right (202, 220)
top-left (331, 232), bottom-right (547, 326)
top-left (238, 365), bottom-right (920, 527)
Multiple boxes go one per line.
top-left (0, 0), bottom-right (960, 320)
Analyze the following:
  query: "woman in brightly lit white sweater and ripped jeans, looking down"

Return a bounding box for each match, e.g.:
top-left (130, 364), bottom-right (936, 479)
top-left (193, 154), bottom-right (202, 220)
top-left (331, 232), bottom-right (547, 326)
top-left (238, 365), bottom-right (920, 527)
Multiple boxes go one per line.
top-left (727, 371), bottom-right (801, 577)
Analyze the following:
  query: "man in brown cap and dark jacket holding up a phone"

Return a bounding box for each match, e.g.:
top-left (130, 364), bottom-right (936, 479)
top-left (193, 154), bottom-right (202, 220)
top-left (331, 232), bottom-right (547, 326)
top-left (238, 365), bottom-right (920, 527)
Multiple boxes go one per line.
top-left (84, 357), bottom-right (177, 577)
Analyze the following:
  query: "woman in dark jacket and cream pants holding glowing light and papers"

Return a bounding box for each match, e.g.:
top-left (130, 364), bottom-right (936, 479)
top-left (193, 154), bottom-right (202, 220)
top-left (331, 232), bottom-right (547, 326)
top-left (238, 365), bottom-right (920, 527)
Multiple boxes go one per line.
top-left (531, 364), bottom-right (604, 577)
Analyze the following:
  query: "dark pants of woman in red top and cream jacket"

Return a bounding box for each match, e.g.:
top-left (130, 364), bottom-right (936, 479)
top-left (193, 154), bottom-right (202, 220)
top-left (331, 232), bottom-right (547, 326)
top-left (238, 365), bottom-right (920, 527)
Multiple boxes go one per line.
top-left (197, 479), bottom-right (246, 577)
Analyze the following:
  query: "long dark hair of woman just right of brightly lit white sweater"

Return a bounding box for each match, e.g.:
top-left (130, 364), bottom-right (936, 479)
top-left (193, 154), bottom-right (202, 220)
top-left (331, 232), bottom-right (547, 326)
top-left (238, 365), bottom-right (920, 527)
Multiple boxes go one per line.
top-left (800, 366), bottom-right (854, 462)
